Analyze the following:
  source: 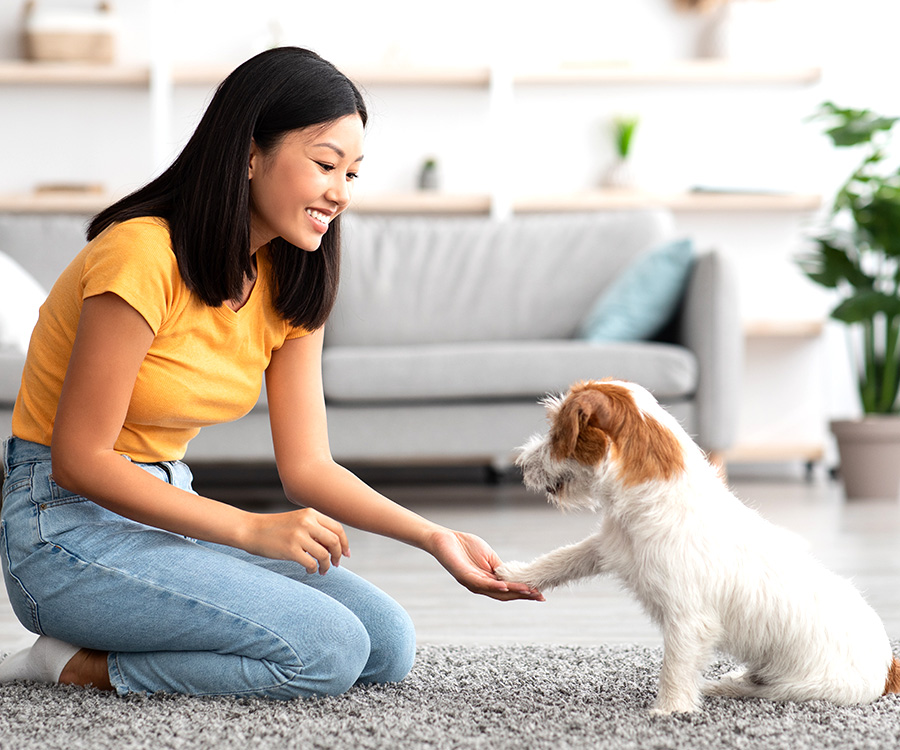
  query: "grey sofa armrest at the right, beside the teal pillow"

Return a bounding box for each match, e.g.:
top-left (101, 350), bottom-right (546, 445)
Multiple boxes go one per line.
top-left (679, 251), bottom-right (744, 453)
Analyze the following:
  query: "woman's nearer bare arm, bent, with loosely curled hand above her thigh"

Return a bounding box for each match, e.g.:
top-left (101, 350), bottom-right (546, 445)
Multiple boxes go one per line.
top-left (51, 293), bottom-right (348, 573)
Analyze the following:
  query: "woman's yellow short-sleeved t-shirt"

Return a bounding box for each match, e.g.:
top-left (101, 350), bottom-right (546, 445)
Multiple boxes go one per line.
top-left (12, 218), bottom-right (305, 462)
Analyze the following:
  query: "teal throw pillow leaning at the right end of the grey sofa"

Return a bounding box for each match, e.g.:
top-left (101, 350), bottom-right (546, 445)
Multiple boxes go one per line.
top-left (577, 239), bottom-right (694, 341)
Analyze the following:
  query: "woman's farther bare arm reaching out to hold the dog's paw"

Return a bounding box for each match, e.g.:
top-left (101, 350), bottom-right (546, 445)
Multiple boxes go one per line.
top-left (266, 330), bottom-right (541, 599)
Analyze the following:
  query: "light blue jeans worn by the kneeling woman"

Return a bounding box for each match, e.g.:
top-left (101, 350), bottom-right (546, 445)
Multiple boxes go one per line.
top-left (0, 438), bottom-right (415, 699)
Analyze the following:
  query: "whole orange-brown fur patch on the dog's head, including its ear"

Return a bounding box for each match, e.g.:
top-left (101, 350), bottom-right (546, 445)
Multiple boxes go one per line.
top-left (550, 381), bottom-right (684, 485)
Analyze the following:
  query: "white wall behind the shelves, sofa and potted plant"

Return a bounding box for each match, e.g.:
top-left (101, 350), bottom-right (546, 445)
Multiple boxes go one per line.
top-left (0, 0), bottom-right (900, 462)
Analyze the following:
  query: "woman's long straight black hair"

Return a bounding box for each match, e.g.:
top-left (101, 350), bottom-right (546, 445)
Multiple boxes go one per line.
top-left (87, 47), bottom-right (368, 329)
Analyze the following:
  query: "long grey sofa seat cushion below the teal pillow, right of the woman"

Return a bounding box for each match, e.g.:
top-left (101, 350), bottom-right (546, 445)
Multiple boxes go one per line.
top-left (322, 340), bottom-right (697, 403)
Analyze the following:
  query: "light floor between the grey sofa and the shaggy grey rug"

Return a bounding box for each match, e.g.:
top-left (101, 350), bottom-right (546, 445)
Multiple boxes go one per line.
top-left (0, 477), bottom-right (900, 650)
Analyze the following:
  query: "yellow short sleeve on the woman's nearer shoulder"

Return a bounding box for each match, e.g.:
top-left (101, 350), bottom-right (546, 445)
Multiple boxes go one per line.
top-left (82, 219), bottom-right (180, 334)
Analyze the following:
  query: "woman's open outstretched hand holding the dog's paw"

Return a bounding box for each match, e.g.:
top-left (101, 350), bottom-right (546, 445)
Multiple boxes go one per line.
top-left (427, 529), bottom-right (544, 602)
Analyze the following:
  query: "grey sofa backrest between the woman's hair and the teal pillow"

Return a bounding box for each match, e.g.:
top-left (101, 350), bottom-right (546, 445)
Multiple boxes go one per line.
top-left (325, 210), bottom-right (673, 346)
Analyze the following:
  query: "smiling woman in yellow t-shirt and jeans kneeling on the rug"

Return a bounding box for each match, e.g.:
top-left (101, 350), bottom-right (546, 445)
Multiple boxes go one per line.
top-left (0, 48), bottom-right (540, 699)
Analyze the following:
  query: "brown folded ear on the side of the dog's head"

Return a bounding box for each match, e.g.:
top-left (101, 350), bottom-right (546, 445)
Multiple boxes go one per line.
top-left (550, 388), bottom-right (612, 464)
